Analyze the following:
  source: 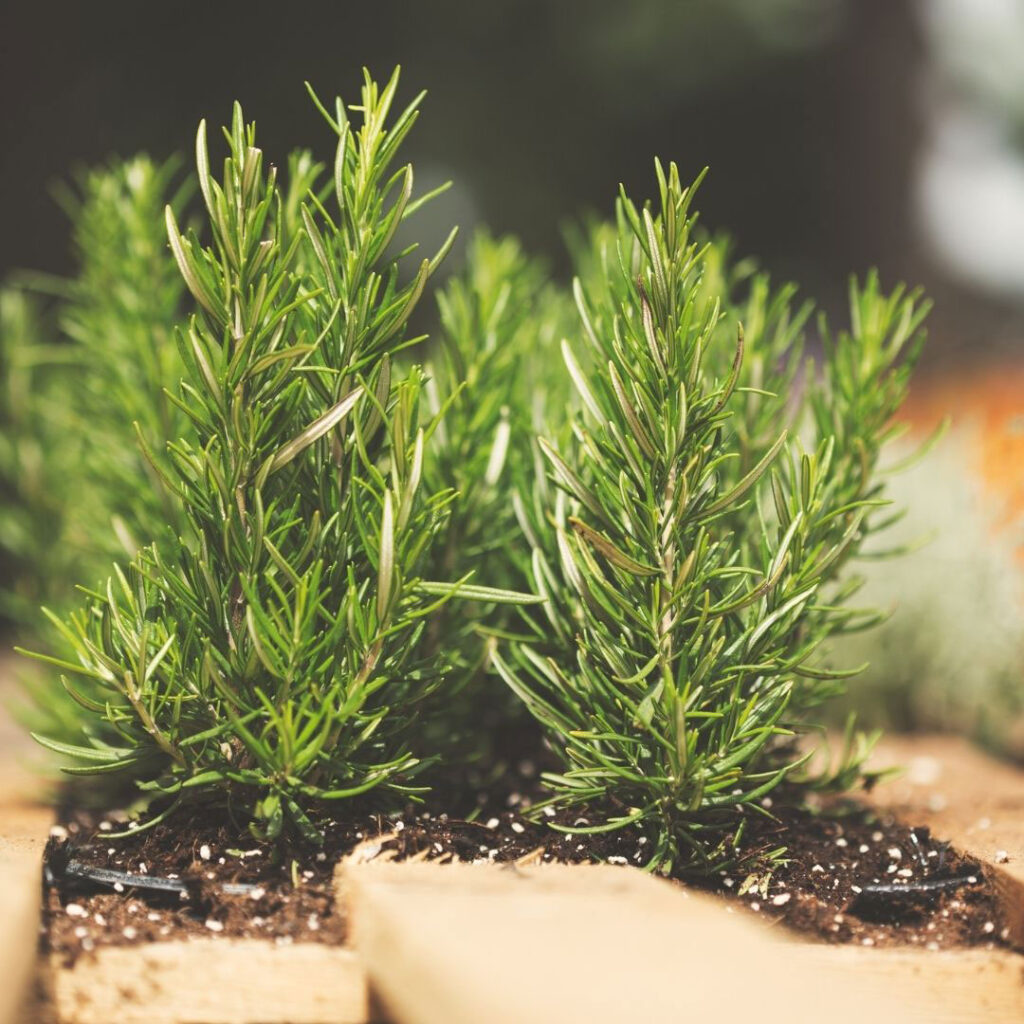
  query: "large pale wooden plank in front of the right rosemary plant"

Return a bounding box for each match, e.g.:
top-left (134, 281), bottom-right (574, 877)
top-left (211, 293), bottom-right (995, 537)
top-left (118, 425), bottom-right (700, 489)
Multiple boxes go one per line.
top-left (339, 863), bottom-right (1024, 1024)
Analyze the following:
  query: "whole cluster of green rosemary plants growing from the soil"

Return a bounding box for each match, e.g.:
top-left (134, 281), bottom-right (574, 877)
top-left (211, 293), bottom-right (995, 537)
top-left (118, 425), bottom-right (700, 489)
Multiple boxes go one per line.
top-left (8, 66), bottom-right (923, 869)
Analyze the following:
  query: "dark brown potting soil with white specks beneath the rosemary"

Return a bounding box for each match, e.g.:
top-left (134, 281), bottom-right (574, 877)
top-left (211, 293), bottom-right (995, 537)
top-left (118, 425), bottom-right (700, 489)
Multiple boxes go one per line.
top-left (42, 762), bottom-right (1006, 963)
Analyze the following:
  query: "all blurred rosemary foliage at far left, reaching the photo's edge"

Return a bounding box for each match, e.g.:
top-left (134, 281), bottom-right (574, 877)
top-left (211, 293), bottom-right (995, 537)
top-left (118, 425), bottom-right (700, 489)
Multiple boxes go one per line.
top-left (3, 157), bottom-right (199, 757)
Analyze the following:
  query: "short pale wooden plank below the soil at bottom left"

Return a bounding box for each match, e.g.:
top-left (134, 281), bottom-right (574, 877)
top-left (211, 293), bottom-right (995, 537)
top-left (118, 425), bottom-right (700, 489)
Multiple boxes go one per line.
top-left (46, 938), bottom-right (372, 1024)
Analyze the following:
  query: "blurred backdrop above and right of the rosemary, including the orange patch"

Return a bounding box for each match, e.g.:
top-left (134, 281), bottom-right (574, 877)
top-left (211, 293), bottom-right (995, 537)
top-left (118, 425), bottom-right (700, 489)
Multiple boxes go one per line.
top-left (0, 0), bottom-right (1024, 753)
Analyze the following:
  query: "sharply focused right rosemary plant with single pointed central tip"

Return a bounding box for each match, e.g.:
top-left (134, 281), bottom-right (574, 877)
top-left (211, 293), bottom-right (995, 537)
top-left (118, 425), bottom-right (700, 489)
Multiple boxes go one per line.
top-left (495, 164), bottom-right (926, 871)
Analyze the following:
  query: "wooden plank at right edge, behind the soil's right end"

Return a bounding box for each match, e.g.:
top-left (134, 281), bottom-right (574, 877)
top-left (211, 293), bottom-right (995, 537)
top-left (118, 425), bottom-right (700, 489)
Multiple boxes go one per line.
top-left (868, 735), bottom-right (1024, 949)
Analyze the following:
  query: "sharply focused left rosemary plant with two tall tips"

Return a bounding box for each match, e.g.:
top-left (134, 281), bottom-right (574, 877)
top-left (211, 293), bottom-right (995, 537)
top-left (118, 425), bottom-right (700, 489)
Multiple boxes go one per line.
top-left (24, 73), bottom-right (521, 842)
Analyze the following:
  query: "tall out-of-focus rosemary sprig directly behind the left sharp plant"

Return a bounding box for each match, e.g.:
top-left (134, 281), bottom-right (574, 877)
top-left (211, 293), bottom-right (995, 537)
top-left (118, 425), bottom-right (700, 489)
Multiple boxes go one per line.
top-left (52, 156), bottom-right (187, 565)
